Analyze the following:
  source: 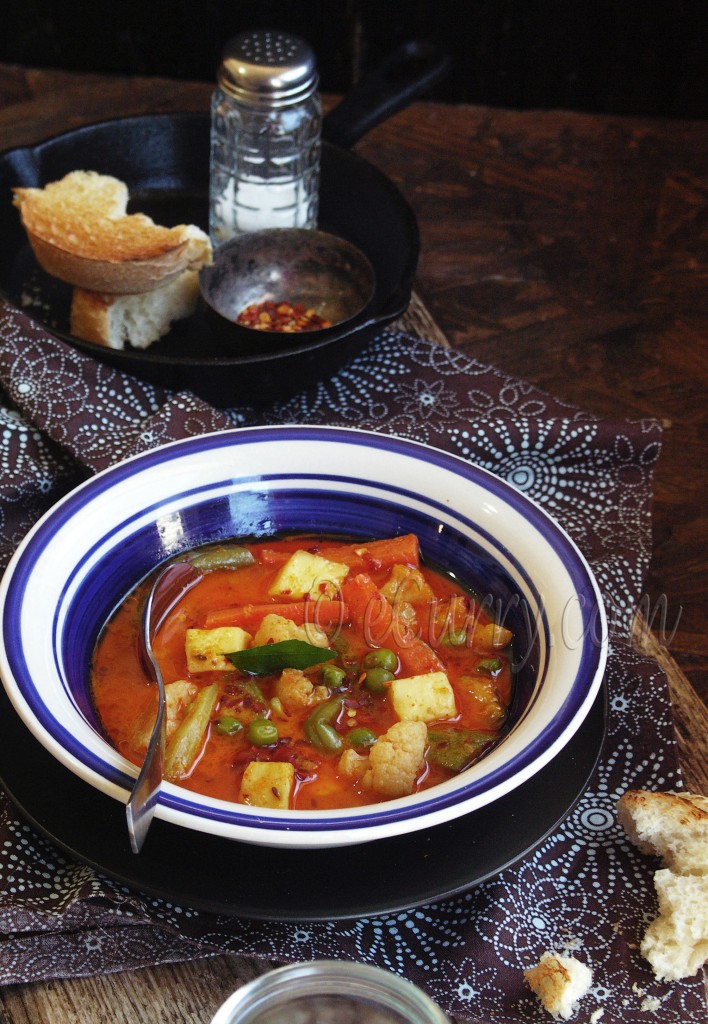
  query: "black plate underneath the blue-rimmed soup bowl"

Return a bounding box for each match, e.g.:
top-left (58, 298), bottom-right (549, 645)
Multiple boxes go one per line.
top-left (0, 687), bottom-right (606, 922)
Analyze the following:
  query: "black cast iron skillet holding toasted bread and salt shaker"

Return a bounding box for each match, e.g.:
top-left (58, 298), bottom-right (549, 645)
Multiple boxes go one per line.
top-left (0, 43), bottom-right (448, 408)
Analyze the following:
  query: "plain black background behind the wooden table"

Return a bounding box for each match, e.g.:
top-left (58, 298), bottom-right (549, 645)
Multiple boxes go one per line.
top-left (0, 0), bottom-right (708, 119)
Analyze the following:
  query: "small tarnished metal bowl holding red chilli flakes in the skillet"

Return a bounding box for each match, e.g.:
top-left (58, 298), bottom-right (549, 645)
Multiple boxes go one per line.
top-left (200, 227), bottom-right (376, 351)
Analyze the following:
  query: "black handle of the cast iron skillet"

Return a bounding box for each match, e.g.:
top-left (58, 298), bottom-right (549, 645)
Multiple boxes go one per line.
top-left (322, 40), bottom-right (452, 150)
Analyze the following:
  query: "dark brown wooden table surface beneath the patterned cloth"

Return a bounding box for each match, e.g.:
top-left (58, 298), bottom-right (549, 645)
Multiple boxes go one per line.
top-left (0, 65), bottom-right (708, 1024)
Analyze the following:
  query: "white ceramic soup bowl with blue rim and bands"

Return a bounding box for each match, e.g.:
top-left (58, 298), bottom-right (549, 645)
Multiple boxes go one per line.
top-left (0, 426), bottom-right (608, 848)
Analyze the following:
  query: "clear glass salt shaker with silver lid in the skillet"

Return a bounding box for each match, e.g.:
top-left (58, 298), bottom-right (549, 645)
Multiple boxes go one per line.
top-left (209, 30), bottom-right (322, 246)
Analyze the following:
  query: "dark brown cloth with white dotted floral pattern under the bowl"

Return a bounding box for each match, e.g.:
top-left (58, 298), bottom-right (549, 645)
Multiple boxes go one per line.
top-left (0, 305), bottom-right (704, 1024)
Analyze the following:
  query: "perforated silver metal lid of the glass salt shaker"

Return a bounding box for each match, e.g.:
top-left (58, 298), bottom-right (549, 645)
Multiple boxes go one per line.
top-left (218, 29), bottom-right (318, 108)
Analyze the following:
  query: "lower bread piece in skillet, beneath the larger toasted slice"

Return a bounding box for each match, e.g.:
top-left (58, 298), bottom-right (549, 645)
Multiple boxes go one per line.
top-left (71, 270), bottom-right (199, 349)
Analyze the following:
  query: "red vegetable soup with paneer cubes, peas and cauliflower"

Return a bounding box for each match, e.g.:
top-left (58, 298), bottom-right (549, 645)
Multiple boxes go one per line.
top-left (91, 535), bottom-right (512, 810)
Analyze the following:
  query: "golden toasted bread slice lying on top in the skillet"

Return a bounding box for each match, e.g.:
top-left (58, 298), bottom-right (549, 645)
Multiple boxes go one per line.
top-left (13, 170), bottom-right (211, 295)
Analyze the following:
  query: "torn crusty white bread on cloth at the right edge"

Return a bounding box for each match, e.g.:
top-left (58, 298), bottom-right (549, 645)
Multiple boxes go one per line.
top-left (617, 790), bottom-right (708, 981)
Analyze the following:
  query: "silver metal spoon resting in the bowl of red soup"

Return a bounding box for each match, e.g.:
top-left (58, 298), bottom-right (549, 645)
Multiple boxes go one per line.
top-left (125, 561), bottom-right (202, 853)
